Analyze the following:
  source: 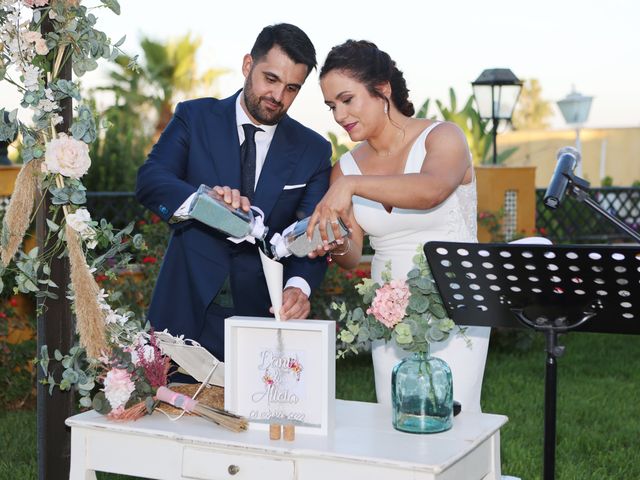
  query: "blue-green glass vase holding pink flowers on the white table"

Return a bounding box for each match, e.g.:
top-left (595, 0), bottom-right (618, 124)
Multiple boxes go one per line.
top-left (391, 346), bottom-right (453, 433)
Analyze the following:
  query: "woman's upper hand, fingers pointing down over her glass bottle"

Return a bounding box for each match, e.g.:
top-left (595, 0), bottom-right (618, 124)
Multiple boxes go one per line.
top-left (307, 176), bottom-right (353, 244)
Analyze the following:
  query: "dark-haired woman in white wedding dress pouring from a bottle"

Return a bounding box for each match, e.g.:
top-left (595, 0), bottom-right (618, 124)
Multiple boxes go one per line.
top-left (308, 40), bottom-right (490, 412)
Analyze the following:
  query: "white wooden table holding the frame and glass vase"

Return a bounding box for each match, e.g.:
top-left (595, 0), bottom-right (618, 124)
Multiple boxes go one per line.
top-left (66, 400), bottom-right (507, 480)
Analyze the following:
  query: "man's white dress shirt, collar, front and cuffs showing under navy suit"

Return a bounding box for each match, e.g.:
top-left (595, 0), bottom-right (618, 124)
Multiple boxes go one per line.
top-left (173, 92), bottom-right (311, 297)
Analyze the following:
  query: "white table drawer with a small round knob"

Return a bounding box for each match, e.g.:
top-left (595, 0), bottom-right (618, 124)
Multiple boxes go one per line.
top-left (182, 447), bottom-right (294, 480)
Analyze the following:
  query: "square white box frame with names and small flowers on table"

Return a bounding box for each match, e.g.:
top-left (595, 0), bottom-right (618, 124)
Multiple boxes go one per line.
top-left (224, 316), bottom-right (336, 435)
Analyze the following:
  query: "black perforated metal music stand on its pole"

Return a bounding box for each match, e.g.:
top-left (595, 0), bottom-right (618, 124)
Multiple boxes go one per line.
top-left (424, 242), bottom-right (640, 480)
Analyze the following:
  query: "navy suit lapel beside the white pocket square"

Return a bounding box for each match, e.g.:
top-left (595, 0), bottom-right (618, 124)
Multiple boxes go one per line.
top-left (253, 116), bottom-right (299, 220)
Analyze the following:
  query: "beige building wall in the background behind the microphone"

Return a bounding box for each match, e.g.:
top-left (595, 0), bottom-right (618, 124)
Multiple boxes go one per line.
top-left (498, 127), bottom-right (640, 188)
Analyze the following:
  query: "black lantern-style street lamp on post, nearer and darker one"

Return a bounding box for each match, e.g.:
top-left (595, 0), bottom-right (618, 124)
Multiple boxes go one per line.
top-left (471, 68), bottom-right (522, 165)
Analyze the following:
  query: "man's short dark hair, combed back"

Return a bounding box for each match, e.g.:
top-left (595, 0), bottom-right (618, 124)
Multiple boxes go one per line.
top-left (251, 23), bottom-right (317, 76)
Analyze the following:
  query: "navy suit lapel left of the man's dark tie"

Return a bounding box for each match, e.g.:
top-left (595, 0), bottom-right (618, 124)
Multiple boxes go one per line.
top-left (205, 92), bottom-right (240, 188)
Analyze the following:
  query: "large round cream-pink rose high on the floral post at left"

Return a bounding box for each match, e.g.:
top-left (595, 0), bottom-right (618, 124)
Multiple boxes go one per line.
top-left (44, 133), bottom-right (91, 178)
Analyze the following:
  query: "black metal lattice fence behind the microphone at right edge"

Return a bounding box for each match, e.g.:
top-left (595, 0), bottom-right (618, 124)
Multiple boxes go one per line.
top-left (536, 187), bottom-right (640, 244)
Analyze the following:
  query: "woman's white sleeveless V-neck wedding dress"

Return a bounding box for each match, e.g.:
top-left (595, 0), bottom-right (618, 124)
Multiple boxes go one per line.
top-left (340, 123), bottom-right (491, 412)
